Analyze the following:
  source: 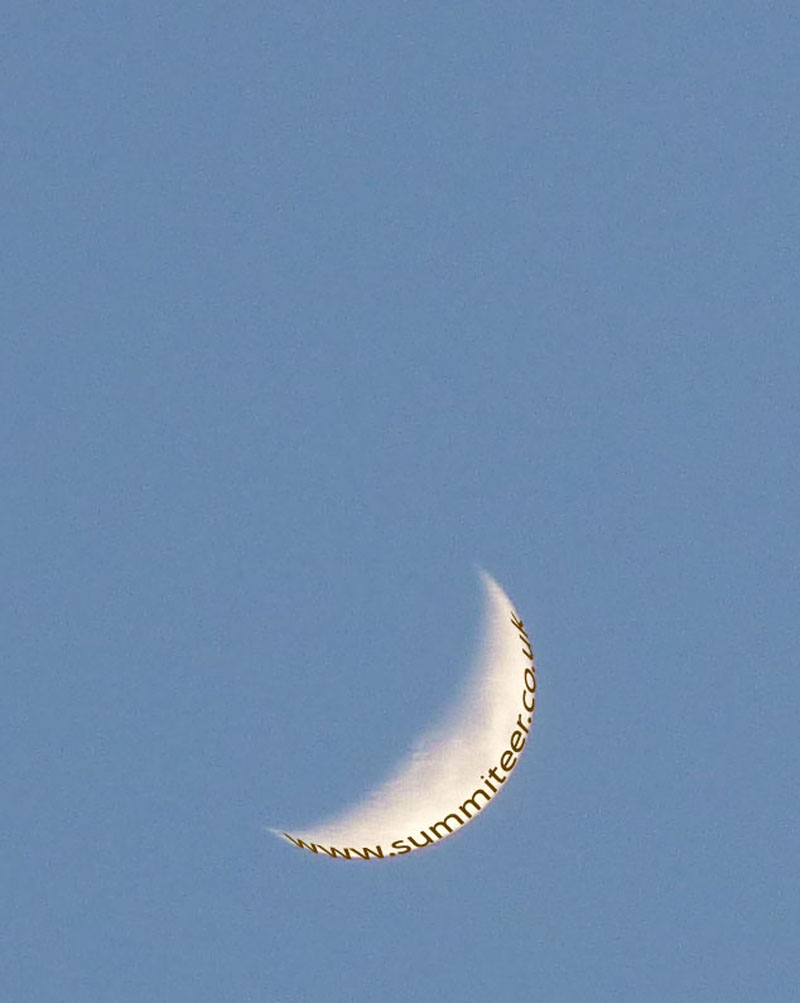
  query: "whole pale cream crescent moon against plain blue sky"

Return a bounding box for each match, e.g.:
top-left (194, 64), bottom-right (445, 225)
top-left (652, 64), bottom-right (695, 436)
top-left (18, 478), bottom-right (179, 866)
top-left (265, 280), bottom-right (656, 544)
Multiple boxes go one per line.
top-left (272, 572), bottom-right (536, 861)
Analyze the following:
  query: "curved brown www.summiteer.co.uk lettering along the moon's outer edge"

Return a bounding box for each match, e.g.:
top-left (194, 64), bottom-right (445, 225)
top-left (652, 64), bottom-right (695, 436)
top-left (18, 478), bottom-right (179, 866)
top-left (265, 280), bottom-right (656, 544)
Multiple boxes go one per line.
top-left (284, 613), bottom-right (536, 861)
